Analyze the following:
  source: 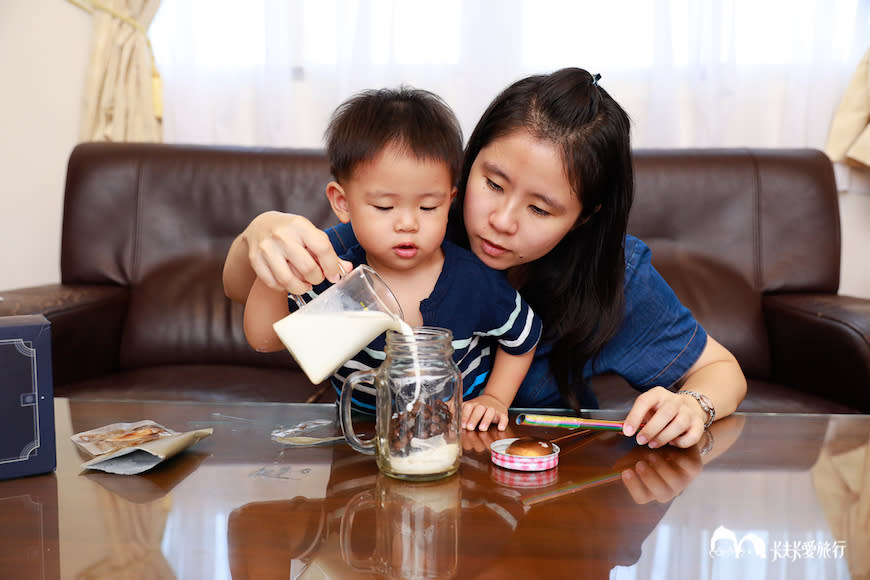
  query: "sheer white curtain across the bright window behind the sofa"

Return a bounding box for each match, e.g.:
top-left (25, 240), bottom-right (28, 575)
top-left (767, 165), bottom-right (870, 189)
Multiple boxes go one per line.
top-left (150, 0), bottom-right (870, 149)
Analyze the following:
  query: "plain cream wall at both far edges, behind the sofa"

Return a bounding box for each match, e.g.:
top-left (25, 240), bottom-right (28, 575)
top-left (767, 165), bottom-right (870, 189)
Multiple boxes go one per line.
top-left (0, 0), bottom-right (870, 297)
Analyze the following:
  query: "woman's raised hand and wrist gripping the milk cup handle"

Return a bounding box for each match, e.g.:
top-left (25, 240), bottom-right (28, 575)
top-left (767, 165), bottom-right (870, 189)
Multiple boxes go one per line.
top-left (223, 211), bottom-right (351, 303)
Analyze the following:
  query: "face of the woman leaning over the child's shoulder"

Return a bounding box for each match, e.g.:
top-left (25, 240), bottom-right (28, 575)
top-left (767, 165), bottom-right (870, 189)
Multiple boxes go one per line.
top-left (463, 131), bottom-right (583, 270)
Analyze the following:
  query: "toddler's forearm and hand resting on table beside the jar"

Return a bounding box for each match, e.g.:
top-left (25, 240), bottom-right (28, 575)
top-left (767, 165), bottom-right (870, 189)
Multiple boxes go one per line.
top-left (462, 348), bottom-right (535, 431)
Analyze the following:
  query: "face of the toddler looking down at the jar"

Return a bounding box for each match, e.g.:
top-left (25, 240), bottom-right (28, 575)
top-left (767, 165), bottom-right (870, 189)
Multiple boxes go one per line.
top-left (343, 147), bottom-right (455, 274)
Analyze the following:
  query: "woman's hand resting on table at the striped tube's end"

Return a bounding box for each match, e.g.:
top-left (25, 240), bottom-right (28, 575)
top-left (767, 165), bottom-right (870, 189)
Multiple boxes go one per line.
top-left (622, 387), bottom-right (707, 449)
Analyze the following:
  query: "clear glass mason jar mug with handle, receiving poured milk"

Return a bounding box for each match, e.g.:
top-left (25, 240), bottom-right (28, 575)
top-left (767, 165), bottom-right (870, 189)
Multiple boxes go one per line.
top-left (341, 327), bottom-right (462, 480)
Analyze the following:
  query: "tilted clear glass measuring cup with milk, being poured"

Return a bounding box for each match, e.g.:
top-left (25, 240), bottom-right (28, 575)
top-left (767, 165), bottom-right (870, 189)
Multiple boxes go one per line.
top-left (273, 265), bottom-right (410, 384)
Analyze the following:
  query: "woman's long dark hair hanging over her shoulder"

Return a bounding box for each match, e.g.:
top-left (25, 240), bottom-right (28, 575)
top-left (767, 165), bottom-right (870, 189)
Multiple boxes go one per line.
top-left (448, 68), bottom-right (634, 410)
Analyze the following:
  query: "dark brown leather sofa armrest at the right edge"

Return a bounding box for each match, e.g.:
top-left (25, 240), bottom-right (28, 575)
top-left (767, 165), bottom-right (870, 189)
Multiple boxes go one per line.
top-left (763, 294), bottom-right (870, 413)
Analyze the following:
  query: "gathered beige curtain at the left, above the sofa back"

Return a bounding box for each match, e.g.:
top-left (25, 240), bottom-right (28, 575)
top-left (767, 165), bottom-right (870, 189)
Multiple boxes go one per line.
top-left (69, 0), bottom-right (163, 142)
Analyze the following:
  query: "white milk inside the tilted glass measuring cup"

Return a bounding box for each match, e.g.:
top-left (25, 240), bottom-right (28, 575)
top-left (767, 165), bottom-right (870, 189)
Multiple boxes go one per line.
top-left (272, 309), bottom-right (404, 384)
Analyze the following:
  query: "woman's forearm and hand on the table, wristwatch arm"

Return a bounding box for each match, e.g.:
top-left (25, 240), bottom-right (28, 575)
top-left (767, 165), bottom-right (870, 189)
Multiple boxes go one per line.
top-left (623, 336), bottom-right (746, 448)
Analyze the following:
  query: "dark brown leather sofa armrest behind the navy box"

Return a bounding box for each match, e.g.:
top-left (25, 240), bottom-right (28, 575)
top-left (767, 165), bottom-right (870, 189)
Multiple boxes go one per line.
top-left (0, 284), bottom-right (129, 385)
